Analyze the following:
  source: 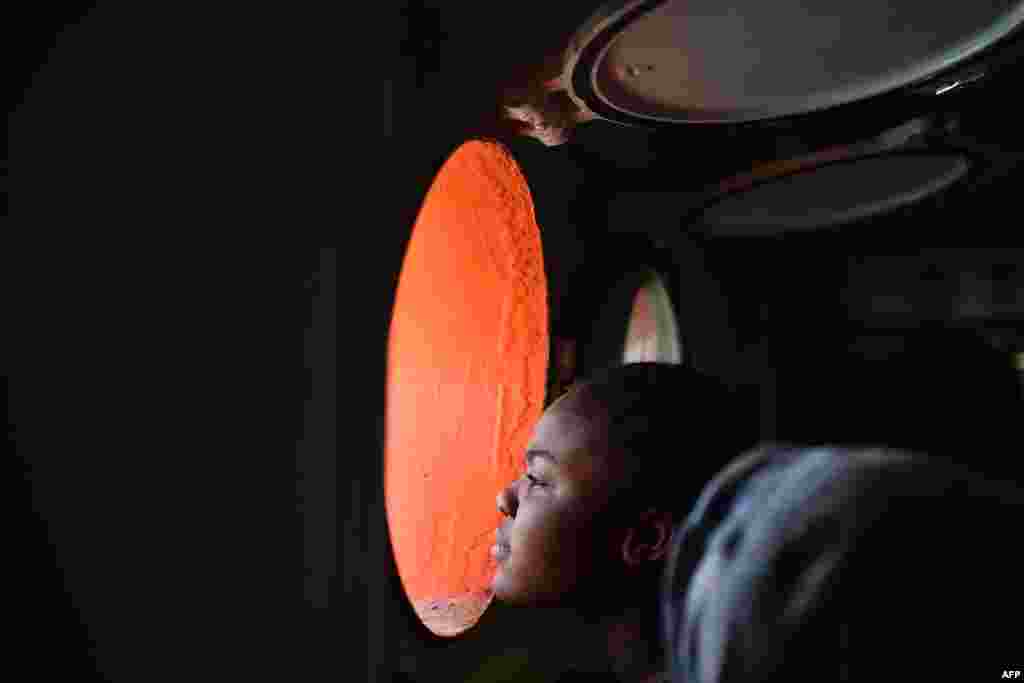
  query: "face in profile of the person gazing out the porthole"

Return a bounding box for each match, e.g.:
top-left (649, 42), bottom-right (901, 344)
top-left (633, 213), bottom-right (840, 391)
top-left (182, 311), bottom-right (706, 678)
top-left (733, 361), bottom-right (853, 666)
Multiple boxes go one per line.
top-left (492, 390), bottom-right (611, 605)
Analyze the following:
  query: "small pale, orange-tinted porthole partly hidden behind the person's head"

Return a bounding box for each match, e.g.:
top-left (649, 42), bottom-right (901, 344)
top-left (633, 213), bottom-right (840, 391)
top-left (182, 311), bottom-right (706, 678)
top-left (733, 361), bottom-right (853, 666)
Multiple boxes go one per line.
top-left (623, 271), bottom-right (683, 364)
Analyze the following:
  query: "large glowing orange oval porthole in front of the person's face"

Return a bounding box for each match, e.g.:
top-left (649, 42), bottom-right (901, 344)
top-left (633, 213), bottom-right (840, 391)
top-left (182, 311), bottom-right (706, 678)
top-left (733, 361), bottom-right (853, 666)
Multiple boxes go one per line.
top-left (384, 140), bottom-right (548, 636)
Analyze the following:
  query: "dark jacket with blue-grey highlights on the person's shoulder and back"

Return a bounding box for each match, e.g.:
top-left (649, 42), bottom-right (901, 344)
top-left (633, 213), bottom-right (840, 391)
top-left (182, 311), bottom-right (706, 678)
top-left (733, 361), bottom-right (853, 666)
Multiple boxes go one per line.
top-left (662, 445), bottom-right (1024, 683)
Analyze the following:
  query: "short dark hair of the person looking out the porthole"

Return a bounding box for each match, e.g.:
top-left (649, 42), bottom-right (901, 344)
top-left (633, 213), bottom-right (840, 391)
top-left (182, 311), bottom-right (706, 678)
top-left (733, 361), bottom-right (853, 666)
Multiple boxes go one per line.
top-left (573, 362), bottom-right (757, 520)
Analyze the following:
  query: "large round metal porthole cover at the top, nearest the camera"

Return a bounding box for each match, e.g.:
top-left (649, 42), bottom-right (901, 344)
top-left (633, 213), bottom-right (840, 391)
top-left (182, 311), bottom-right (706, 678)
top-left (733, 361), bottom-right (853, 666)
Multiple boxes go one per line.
top-left (573, 0), bottom-right (1024, 123)
